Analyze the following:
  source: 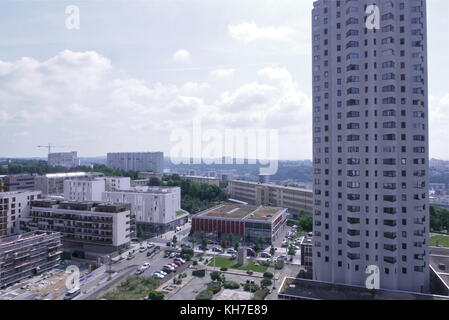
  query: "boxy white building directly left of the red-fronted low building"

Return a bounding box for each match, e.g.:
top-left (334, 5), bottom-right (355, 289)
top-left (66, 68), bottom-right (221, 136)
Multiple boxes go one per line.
top-left (103, 187), bottom-right (188, 235)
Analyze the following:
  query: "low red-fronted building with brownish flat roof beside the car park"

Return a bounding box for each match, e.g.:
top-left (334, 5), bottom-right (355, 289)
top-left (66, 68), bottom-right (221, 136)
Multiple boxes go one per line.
top-left (192, 204), bottom-right (287, 243)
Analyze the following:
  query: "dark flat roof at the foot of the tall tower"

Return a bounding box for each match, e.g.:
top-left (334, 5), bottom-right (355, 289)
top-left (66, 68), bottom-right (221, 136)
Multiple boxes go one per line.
top-left (278, 278), bottom-right (449, 300)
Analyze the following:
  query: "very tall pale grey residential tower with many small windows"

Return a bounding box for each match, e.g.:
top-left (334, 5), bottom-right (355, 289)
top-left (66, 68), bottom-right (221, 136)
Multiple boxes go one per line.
top-left (312, 0), bottom-right (429, 292)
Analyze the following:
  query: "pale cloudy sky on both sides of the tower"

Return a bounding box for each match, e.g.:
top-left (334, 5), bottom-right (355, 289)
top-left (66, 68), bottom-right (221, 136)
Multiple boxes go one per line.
top-left (0, 0), bottom-right (449, 159)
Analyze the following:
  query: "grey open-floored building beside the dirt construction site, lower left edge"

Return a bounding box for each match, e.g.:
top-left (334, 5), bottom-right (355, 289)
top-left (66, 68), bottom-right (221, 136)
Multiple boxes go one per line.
top-left (0, 231), bottom-right (62, 287)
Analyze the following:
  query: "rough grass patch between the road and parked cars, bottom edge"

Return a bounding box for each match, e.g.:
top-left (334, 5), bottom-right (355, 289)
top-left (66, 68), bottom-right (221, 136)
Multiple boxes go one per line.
top-left (102, 276), bottom-right (160, 300)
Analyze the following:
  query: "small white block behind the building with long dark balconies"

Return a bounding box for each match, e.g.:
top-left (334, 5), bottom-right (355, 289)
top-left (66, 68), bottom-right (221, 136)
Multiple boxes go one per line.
top-left (64, 178), bottom-right (106, 201)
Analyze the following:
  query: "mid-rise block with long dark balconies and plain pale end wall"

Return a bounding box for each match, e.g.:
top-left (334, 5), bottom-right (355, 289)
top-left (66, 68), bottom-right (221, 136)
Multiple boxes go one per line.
top-left (21, 199), bottom-right (131, 261)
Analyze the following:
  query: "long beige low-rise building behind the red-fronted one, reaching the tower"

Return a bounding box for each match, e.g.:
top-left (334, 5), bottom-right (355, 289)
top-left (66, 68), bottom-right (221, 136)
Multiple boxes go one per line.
top-left (228, 180), bottom-right (313, 216)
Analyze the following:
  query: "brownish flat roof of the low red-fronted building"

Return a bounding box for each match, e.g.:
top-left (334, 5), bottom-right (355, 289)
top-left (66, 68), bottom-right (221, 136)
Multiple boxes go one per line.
top-left (199, 204), bottom-right (285, 221)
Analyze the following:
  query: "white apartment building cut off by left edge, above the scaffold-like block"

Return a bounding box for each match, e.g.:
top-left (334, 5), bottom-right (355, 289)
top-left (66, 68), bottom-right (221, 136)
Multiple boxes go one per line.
top-left (0, 191), bottom-right (41, 237)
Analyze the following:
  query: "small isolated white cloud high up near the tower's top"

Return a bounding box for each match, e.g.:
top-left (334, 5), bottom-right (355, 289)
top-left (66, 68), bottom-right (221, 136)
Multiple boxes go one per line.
top-left (228, 22), bottom-right (296, 42)
